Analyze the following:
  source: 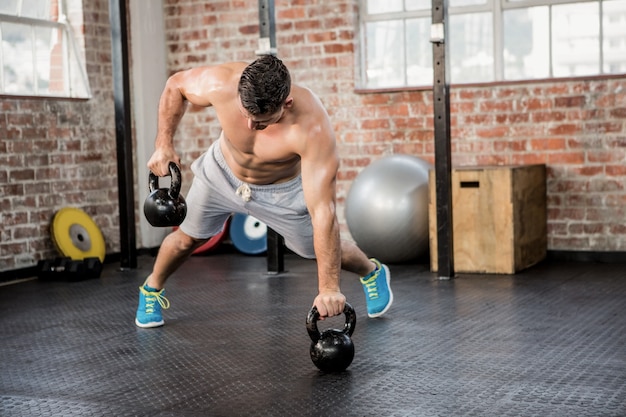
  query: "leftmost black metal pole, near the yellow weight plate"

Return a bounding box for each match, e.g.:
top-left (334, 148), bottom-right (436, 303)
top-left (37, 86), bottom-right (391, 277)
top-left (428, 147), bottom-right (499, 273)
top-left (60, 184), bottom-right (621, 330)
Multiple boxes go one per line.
top-left (109, 0), bottom-right (137, 269)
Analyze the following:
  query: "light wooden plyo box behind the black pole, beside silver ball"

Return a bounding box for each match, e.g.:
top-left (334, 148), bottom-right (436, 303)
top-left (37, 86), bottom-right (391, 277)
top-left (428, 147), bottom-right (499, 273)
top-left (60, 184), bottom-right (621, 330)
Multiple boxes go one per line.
top-left (428, 165), bottom-right (547, 274)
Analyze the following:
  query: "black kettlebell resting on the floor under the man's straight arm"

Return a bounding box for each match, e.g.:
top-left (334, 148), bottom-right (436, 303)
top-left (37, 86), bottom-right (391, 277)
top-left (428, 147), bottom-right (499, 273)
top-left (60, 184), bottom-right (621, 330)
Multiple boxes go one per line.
top-left (306, 303), bottom-right (356, 372)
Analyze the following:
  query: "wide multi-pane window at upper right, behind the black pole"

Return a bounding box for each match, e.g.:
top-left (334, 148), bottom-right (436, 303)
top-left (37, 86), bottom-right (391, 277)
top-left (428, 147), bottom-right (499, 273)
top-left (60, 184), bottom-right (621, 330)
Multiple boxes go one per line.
top-left (360, 0), bottom-right (626, 88)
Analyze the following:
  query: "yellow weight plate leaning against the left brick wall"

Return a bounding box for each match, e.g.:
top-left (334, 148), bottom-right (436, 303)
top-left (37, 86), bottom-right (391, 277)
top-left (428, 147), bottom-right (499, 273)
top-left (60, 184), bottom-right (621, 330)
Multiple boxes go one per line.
top-left (50, 207), bottom-right (106, 262)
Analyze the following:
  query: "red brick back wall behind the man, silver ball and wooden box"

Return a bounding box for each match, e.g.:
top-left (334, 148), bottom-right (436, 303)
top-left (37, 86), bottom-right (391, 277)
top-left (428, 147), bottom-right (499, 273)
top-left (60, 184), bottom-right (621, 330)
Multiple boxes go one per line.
top-left (166, 0), bottom-right (626, 251)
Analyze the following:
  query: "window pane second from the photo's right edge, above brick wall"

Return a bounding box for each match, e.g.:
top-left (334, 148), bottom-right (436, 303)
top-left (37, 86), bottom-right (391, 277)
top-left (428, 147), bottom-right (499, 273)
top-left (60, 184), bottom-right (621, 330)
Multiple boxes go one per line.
top-left (552, 2), bottom-right (600, 77)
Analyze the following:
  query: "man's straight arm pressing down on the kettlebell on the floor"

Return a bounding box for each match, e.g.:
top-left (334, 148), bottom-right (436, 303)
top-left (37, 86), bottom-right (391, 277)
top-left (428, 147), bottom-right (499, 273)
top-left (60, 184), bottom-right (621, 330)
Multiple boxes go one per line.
top-left (301, 104), bottom-right (346, 317)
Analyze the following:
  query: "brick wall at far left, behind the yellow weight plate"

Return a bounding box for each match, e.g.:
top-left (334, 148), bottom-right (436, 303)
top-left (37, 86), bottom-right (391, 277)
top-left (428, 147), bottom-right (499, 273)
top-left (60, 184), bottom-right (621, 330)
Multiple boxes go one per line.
top-left (0, 0), bottom-right (119, 271)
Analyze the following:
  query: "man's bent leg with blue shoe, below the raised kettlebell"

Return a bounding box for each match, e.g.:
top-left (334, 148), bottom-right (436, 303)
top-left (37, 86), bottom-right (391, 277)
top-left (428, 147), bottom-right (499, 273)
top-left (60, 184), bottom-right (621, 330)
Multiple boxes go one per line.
top-left (135, 229), bottom-right (206, 328)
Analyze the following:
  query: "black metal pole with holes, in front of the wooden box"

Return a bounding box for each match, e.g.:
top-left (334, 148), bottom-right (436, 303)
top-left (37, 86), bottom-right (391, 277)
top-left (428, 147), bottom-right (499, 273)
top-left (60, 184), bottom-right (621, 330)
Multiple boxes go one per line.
top-left (430, 0), bottom-right (454, 279)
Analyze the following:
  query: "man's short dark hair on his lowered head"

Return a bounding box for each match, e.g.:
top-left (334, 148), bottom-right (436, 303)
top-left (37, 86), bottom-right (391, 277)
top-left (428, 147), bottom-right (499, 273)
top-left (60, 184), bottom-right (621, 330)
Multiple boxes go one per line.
top-left (238, 55), bottom-right (291, 116)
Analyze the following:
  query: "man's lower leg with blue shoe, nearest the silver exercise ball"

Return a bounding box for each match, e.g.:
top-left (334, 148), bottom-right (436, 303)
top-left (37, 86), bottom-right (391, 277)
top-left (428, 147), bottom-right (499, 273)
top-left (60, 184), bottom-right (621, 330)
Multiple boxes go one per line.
top-left (341, 240), bottom-right (393, 317)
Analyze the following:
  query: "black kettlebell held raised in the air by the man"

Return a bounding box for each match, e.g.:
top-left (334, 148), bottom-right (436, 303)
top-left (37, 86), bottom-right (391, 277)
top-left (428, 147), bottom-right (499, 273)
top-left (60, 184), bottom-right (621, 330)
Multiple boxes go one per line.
top-left (143, 162), bottom-right (187, 227)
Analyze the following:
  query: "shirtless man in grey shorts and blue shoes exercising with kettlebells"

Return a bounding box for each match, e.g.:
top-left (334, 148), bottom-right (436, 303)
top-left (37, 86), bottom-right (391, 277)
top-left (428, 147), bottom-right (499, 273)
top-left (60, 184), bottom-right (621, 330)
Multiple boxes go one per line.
top-left (135, 55), bottom-right (393, 328)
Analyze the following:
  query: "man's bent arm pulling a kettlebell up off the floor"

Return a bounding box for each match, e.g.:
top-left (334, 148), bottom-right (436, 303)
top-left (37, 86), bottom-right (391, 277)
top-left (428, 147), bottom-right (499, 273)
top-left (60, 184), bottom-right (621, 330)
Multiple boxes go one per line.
top-left (148, 65), bottom-right (231, 176)
